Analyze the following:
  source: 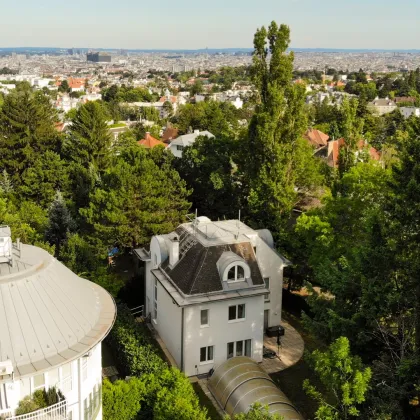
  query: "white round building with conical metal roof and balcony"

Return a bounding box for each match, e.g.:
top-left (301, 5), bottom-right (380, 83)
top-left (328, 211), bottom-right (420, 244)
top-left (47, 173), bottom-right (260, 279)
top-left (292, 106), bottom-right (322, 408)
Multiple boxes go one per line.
top-left (0, 226), bottom-right (116, 420)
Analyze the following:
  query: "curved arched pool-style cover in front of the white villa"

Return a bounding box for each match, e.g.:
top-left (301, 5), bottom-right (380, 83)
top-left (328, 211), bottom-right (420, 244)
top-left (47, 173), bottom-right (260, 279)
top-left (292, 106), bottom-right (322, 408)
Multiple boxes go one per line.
top-left (208, 356), bottom-right (303, 420)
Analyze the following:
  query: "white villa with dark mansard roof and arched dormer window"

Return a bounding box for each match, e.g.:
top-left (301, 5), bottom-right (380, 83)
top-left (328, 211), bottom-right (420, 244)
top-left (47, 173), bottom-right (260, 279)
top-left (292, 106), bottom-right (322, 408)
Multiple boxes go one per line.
top-left (135, 217), bottom-right (288, 376)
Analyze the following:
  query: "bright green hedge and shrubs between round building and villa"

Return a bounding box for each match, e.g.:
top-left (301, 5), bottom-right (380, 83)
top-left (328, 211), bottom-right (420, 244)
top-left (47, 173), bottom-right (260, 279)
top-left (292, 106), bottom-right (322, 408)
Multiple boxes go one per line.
top-left (102, 305), bottom-right (208, 420)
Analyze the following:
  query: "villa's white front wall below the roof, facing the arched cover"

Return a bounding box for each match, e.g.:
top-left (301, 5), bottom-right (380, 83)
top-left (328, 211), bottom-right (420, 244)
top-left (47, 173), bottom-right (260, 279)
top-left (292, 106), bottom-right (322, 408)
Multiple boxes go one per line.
top-left (184, 296), bottom-right (264, 376)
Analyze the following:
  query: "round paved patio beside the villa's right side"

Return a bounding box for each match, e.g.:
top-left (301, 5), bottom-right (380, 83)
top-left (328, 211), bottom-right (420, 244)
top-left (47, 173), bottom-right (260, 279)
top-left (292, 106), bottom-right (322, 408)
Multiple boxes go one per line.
top-left (261, 321), bottom-right (305, 373)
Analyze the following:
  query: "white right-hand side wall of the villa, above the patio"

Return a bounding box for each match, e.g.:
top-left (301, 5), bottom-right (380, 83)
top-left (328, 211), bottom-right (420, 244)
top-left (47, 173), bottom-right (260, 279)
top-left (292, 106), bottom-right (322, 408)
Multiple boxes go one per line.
top-left (257, 238), bottom-right (283, 327)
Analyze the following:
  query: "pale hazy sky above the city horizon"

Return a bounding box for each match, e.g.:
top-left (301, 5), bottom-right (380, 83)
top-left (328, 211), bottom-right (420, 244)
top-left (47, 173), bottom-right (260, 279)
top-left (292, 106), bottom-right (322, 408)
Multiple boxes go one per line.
top-left (0, 0), bottom-right (420, 49)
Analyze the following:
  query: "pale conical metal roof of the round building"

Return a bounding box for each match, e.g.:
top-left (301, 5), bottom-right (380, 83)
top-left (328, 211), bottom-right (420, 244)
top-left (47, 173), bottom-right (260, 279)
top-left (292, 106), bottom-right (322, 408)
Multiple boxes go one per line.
top-left (0, 241), bottom-right (116, 379)
